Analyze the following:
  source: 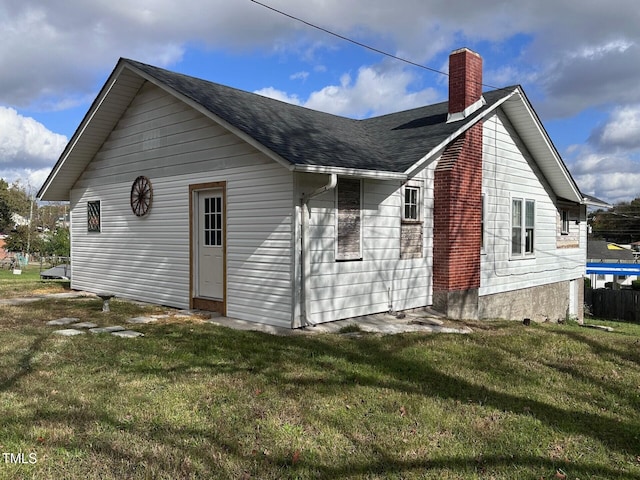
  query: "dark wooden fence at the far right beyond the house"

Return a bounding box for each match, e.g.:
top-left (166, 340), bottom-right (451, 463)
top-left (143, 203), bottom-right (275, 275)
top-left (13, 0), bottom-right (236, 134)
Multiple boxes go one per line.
top-left (584, 288), bottom-right (640, 323)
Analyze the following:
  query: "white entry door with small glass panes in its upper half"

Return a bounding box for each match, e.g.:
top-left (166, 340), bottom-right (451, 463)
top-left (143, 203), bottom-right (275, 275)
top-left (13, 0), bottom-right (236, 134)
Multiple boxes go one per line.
top-left (194, 190), bottom-right (225, 300)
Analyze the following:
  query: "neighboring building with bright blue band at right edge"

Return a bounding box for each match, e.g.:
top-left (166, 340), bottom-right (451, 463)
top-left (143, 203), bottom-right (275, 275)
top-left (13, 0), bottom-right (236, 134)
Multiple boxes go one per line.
top-left (586, 240), bottom-right (640, 288)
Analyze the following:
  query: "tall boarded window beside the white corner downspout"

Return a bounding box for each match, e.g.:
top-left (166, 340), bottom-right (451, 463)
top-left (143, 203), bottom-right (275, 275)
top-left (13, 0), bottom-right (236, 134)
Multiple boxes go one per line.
top-left (336, 178), bottom-right (362, 260)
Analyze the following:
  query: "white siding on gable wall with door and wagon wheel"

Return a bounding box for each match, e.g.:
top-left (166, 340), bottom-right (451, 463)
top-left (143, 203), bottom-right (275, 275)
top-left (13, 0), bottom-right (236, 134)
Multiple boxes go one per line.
top-left (71, 84), bottom-right (293, 327)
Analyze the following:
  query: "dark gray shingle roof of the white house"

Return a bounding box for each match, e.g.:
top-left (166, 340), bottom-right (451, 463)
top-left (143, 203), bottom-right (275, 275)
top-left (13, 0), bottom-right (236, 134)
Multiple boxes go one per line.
top-left (123, 60), bottom-right (516, 172)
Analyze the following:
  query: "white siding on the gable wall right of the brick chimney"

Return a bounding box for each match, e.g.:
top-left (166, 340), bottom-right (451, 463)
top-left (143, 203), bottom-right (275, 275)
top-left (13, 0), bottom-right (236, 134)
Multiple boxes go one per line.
top-left (479, 112), bottom-right (585, 295)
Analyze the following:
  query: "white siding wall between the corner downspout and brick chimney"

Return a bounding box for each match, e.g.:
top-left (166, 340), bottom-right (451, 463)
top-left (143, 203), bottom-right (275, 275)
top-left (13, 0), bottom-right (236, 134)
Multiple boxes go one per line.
top-left (297, 171), bottom-right (433, 322)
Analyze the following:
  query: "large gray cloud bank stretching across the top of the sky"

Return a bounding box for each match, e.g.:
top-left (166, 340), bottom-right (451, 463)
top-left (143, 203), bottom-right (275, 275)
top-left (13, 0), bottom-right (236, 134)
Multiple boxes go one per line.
top-left (0, 0), bottom-right (640, 115)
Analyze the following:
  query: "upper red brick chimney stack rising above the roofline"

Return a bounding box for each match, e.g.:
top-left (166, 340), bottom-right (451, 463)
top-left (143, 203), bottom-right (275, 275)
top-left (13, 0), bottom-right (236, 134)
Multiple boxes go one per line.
top-left (449, 48), bottom-right (484, 121)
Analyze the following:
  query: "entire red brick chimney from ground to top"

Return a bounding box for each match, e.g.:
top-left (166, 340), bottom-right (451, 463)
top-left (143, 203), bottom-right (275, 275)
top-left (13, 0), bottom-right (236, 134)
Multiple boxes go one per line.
top-left (433, 48), bottom-right (484, 319)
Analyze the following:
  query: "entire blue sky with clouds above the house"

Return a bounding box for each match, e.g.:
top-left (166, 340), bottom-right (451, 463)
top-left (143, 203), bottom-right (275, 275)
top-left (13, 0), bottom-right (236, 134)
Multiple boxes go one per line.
top-left (0, 0), bottom-right (640, 202)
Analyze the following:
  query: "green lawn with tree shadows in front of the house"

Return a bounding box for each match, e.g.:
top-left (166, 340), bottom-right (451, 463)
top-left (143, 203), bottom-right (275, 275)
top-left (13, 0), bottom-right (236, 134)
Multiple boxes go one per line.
top-left (0, 286), bottom-right (640, 480)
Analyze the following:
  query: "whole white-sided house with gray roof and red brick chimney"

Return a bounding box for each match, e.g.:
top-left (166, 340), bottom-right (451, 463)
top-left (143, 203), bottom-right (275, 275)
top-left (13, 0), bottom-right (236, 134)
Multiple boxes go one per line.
top-left (38, 49), bottom-right (588, 328)
